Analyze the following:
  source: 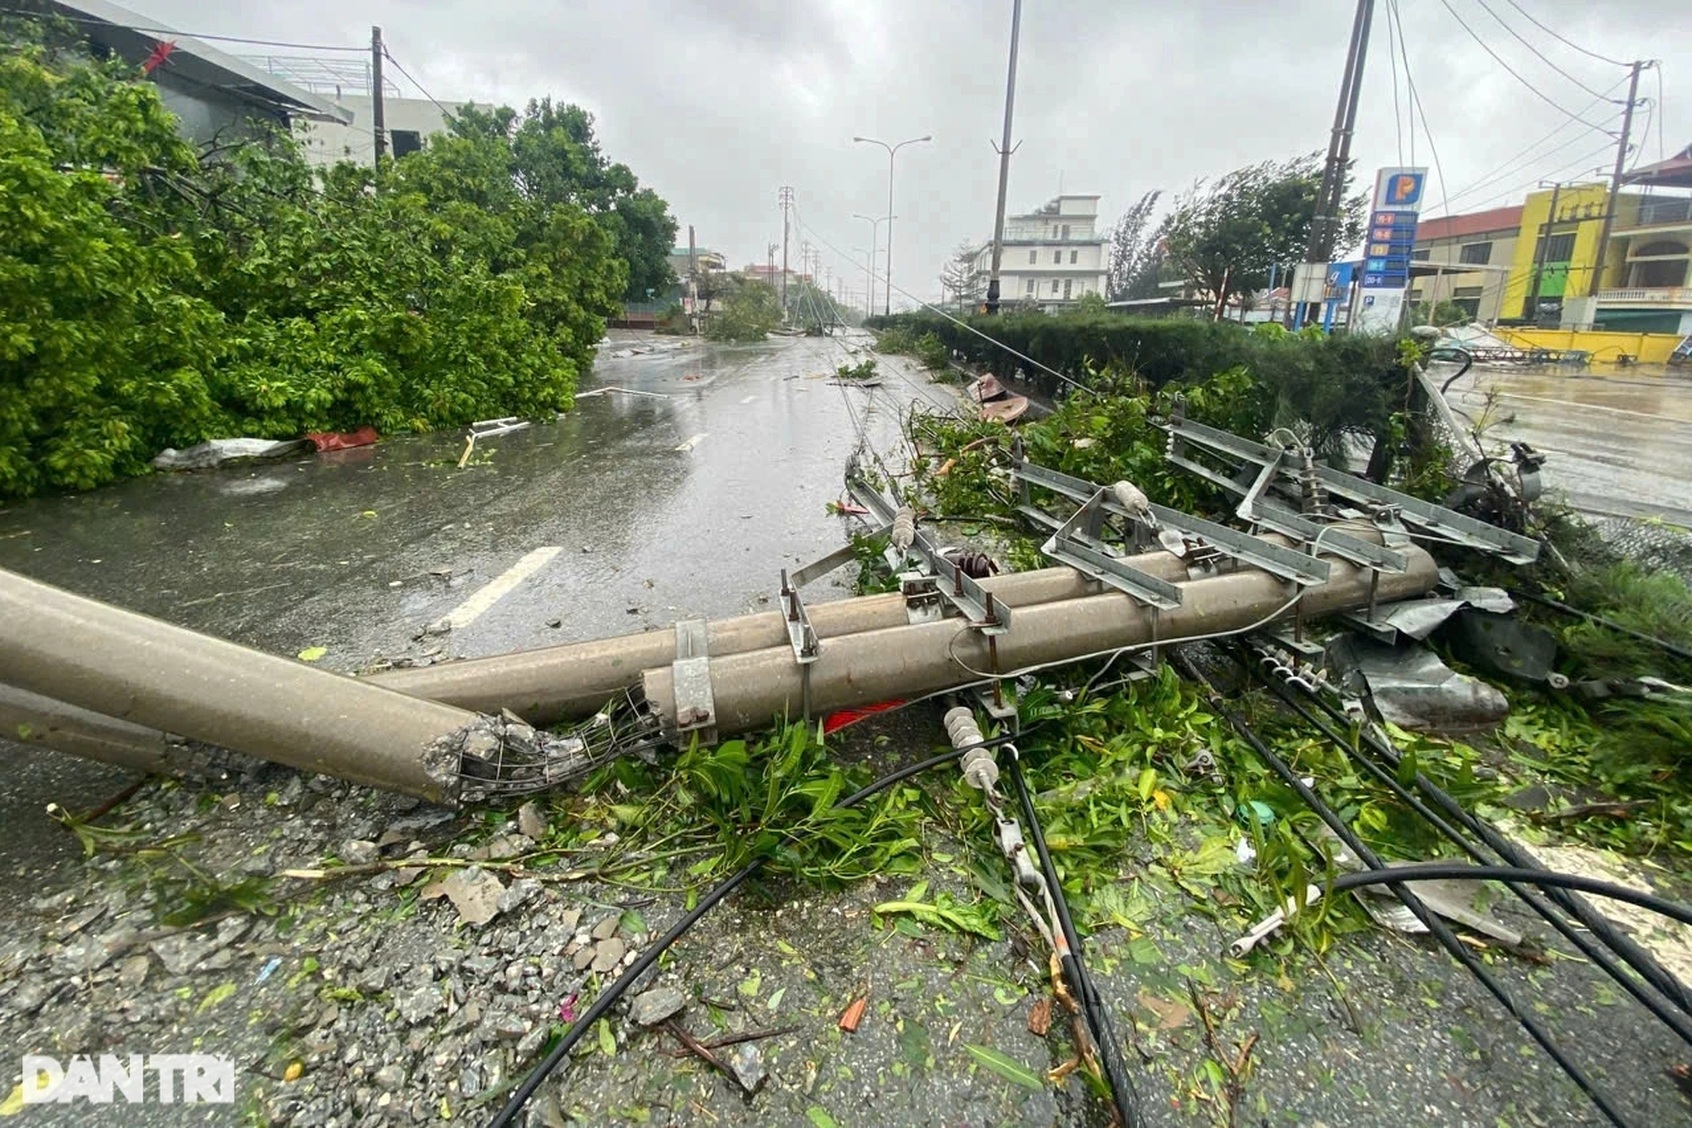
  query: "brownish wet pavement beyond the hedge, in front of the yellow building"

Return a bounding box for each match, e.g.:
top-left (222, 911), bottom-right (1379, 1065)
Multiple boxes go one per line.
top-left (1431, 365), bottom-right (1692, 526)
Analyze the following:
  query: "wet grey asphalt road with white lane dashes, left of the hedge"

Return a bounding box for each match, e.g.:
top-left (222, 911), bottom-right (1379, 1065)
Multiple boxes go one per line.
top-left (0, 333), bottom-right (954, 879)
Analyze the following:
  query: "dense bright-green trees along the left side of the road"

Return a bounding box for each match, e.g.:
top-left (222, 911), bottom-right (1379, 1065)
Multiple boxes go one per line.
top-left (0, 19), bottom-right (675, 497)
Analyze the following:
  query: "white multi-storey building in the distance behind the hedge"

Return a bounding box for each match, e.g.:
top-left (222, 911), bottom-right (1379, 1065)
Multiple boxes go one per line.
top-left (975, 194), bottom-right (1107, 308)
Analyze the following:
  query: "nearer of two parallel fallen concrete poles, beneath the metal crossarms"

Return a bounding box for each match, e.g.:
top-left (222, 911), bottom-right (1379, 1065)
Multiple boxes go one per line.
top-left (643, 548), bottom-right (1438, 734)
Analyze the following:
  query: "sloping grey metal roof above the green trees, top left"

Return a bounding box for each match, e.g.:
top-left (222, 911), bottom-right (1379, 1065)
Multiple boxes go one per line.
top-left (39, 0), bottom-right (352, 125)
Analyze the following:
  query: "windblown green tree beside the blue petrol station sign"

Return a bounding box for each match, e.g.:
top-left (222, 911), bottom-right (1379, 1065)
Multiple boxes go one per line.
top-left (1161, 154), bottom-right (1365, 320)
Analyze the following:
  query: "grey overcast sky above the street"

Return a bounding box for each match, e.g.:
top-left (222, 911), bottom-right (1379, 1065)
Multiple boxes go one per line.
top-left (148, 0), bottom-right (1692, 309)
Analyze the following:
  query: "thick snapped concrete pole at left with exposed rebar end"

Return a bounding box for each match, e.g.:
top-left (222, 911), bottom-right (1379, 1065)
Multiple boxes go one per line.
top-left (0, 570), bottom-right (605, 803)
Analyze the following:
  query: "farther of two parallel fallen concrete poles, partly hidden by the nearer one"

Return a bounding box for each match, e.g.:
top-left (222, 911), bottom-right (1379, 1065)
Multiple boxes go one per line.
top-left (365, 554), bottom-right (1211, 726)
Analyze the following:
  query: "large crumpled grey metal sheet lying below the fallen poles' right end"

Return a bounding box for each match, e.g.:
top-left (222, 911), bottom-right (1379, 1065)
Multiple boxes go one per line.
top-left (1328, 634), bottom-right (1509, 732)
